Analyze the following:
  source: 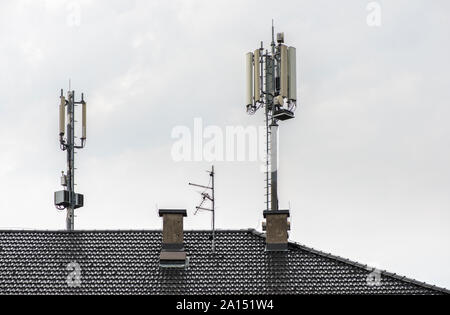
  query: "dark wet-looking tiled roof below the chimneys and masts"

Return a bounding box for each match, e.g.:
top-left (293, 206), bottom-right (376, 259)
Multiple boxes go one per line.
top-left (0, 230), bottom-right (450, 295)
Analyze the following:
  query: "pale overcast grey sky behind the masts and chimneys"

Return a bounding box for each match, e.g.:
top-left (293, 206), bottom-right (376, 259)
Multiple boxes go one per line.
top-left (0, 0), bottom-right (450, 288)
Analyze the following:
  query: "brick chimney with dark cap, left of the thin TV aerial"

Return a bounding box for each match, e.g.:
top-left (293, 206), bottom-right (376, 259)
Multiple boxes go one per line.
top-left (159, 209), bottom-right (187, 267)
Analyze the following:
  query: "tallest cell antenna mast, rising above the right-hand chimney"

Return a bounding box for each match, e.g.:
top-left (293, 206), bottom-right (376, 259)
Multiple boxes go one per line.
top-left (246, 20), bottom-right (297, 211)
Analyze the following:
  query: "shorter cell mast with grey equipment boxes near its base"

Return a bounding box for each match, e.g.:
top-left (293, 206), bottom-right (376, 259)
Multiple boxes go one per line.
top-left (55, 87), bottom-right (86, 231)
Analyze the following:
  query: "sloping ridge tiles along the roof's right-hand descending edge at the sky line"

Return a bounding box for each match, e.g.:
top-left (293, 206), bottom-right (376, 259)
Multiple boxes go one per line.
top-left (250, 229), bottom-right (450, 294)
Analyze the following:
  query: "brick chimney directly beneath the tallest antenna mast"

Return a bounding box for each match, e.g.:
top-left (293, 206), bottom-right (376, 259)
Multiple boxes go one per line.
top-left (263, 210), bottom-right (291, 251)
